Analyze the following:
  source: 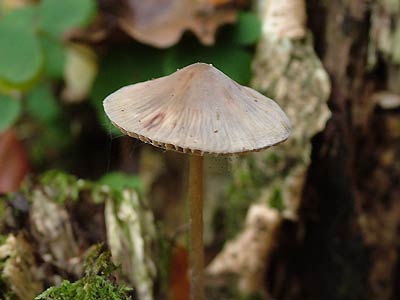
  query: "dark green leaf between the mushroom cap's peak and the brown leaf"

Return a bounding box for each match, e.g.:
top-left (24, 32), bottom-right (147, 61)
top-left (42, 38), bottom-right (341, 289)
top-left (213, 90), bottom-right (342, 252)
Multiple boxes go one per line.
top-left (164, 41), bottom-right (252, 84)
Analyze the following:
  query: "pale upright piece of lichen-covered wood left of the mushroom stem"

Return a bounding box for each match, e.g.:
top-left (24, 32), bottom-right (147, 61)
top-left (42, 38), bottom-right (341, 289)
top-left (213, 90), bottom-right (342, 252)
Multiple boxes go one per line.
top-left (105, 189), bottom-right (156, 300)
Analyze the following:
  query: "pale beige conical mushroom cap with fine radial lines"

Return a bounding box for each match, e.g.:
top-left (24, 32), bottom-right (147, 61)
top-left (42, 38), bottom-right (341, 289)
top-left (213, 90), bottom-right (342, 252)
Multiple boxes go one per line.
top-left (103, 63), bottom-right (290, 155)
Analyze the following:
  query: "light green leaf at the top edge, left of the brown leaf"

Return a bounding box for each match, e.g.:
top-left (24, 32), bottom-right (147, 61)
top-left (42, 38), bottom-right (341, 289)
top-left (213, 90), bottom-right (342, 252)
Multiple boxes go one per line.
top-left (39, 0), bottom-right (96, 36)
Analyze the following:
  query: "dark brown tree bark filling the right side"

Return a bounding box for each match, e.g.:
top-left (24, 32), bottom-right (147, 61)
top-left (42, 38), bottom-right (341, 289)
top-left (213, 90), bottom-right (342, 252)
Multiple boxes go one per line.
top-left (267, 0), bottom-right (400, 300)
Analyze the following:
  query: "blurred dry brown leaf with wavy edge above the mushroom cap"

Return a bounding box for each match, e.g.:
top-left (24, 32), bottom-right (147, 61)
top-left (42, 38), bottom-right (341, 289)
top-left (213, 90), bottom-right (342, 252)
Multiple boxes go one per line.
top-left (116, 0), bottom-right (236, 48)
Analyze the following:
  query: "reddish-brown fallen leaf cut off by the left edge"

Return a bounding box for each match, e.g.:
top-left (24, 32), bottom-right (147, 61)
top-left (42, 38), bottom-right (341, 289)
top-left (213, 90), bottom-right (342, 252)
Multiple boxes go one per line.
top-left (0, 129), bottom-right (28, 193)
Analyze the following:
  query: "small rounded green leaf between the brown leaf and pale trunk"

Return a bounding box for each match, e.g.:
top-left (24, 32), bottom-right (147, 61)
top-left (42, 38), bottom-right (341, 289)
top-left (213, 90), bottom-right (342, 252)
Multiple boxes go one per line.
top-left (233, 12), bottom-right (261, 46)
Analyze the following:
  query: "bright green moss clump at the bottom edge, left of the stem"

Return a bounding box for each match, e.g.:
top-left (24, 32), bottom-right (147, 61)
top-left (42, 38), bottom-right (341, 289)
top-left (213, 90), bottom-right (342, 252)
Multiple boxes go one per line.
top-left (35, 246), bottom-right (132, 300)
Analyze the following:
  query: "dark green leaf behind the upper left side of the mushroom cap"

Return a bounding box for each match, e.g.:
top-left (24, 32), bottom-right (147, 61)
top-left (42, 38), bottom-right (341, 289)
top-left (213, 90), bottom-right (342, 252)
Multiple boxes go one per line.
top-left (91, 43), bottom-right (165, 135)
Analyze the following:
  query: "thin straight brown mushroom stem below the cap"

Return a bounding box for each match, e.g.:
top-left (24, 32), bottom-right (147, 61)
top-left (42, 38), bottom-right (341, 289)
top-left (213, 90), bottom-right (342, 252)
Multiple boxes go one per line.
top-left (189, 155), bottom-right (204, 300)
